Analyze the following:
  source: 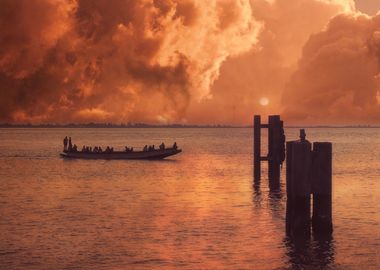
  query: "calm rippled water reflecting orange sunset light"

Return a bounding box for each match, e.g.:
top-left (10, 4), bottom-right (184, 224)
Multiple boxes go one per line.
top-left (0, 129), bottom-right (380, 269)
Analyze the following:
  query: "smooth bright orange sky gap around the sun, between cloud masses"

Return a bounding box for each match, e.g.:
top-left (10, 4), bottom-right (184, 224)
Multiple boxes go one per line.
top-left (189, 0), bottom-right (354, 124)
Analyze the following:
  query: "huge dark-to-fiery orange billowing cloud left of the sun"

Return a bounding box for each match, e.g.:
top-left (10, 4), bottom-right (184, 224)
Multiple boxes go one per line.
top-left (0, 0), bottom-right (261, 122)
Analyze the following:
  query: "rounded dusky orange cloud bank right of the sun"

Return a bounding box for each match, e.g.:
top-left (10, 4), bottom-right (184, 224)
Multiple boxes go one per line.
top-left (283, 14), bottom-right (380, 124)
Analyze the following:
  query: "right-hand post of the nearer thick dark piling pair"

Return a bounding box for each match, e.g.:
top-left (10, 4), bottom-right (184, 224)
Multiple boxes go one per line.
top-left (311, 142), bottom-right (333, 234)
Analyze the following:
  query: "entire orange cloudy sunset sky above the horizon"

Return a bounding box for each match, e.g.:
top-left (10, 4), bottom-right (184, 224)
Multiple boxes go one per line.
top-left (0, 0), bottom-right (380, 125)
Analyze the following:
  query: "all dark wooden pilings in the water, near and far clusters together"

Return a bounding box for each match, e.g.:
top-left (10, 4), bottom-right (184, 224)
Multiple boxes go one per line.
top-left (253, 115), bottom-right (333, 237)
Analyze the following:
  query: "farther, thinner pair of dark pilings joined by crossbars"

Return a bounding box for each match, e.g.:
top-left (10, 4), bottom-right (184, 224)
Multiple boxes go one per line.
top-left (253, 115), bottom-right (285, 188)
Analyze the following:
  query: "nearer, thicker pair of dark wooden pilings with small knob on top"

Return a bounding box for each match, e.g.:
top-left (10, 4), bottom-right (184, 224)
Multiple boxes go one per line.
top-left (286, 129), bottom-right (333, 237)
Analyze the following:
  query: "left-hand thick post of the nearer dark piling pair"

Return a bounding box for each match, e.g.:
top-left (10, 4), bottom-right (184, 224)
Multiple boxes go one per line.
top-left (287, 140), bottom-right (311, 237)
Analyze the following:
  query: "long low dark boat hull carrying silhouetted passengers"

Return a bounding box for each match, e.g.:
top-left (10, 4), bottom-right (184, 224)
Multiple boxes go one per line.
top-left (60, 148), bottom-right (182, 159)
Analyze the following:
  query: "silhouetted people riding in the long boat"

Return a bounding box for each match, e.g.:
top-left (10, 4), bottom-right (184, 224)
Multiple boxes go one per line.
top-left (63, 136), bottom-right (177, 153)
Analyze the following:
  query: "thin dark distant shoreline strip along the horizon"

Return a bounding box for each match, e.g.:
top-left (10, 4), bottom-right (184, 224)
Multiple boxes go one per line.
top-left (0, 123), bottom-right (380, 128)
